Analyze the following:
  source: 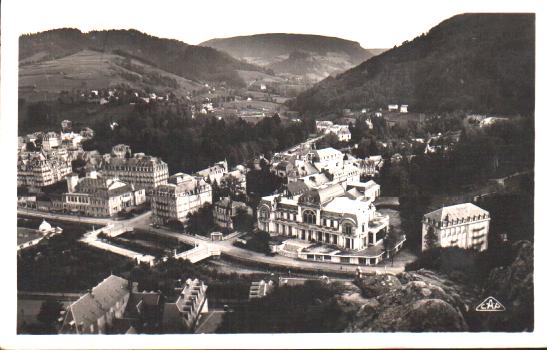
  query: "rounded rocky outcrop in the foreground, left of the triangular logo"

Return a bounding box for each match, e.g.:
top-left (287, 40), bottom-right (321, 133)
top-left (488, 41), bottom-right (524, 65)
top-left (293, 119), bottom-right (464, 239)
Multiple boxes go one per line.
top-left (346, 270), bottom-right (474, 332)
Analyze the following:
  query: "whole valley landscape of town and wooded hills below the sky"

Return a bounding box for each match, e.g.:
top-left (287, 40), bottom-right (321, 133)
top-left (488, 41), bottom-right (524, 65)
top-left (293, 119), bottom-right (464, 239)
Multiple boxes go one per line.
top-left (12, 14), bottom-right (535, 340)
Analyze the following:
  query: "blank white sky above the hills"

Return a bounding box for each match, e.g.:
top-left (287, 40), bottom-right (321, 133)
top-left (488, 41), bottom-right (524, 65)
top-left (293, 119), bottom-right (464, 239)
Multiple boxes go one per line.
top-left (4, 0), bottom-right (539, 48)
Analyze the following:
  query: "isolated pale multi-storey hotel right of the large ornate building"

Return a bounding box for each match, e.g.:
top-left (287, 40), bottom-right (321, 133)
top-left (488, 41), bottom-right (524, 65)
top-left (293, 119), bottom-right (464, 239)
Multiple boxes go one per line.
top-left (422, 203), bottom-right (490, 251)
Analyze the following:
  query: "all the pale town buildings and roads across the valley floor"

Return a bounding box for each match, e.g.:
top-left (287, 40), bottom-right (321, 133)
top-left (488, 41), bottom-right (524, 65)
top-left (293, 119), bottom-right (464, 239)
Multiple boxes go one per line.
top-left (17, 100), bottom-right (532, 334)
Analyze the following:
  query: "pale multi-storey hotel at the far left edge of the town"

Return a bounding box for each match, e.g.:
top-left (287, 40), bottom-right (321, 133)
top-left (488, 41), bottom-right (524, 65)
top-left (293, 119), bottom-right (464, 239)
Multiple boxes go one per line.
top-left (17, 152), bottom-right (72, 190)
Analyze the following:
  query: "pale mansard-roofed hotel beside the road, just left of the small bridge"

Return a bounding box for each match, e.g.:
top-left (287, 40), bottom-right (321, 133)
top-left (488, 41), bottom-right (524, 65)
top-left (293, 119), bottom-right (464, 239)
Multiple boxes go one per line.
top-left (150, 173), bottom-right (213, 225)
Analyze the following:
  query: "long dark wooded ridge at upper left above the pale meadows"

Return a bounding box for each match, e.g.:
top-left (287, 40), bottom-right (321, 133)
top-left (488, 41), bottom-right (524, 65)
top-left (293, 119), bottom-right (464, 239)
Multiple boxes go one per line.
top-left (19, 28), bottom-right (261, 85)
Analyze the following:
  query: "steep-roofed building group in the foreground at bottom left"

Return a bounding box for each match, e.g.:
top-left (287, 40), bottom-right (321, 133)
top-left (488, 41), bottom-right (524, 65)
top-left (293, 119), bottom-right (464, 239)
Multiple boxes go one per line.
top-left (59, 275), bottom-right (198, 334)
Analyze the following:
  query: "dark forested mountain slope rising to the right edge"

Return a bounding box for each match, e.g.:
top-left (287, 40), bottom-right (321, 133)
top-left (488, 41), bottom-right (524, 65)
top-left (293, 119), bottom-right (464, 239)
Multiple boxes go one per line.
top-left (293, 14), bottom-right (535, 115)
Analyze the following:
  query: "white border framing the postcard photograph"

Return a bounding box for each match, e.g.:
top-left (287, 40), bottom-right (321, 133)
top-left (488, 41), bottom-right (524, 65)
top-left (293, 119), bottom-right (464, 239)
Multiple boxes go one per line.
top-left (0, 0), bottom-right (547, 349)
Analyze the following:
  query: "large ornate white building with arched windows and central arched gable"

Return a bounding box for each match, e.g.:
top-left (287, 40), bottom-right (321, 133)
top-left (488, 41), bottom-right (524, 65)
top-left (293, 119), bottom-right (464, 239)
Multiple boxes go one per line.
top-left (258, 183), bottom-right (389, 250)
